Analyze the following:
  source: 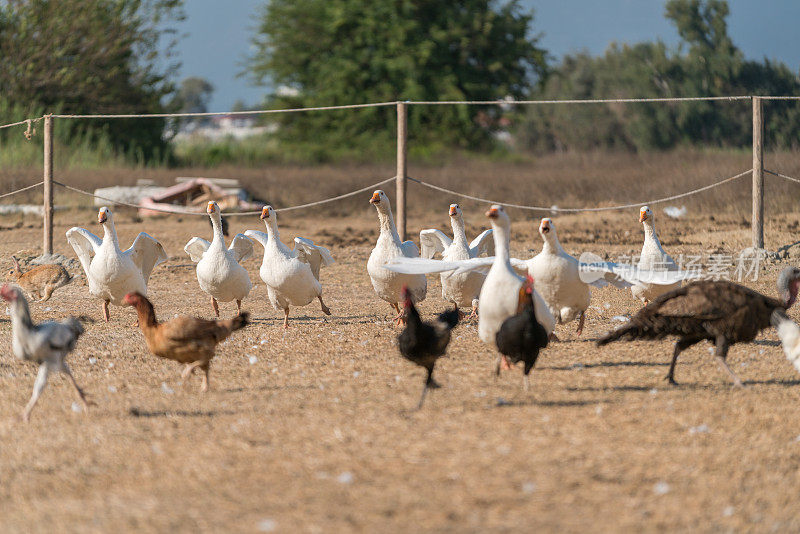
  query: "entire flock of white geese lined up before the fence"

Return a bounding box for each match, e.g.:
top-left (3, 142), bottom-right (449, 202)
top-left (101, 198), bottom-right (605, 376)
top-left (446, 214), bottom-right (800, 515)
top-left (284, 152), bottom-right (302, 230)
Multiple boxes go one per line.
top-left (61, 190), bottom-right (687, 352)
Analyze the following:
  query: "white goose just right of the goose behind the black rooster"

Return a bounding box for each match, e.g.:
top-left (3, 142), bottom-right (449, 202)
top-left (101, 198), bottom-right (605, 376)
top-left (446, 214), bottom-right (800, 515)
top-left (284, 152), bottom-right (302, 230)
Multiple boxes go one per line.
top-left (526, 218), bottom-right (592, 335)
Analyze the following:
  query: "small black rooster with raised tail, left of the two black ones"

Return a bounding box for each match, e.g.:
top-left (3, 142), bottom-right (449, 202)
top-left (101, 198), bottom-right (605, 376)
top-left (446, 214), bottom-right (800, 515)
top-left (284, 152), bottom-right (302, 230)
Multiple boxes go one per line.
top-left (397, 285), bottom-right (458, 409)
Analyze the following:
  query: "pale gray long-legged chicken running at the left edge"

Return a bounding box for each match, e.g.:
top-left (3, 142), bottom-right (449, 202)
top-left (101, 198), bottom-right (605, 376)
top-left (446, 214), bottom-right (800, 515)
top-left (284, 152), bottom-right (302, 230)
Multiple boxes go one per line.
top-left (0, 284), bottom-right (90, 422)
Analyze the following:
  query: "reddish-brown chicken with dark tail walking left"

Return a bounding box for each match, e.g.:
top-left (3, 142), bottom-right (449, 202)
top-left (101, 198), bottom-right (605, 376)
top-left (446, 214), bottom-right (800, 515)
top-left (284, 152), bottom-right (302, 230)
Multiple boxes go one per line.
top-left (125, 293), bottom-right (249, 391)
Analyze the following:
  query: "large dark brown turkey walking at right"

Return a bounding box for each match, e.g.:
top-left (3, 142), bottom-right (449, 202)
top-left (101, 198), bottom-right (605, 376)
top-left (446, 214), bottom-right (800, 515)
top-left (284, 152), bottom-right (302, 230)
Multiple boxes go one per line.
top-left (597, 267), bottom-right (800, 386)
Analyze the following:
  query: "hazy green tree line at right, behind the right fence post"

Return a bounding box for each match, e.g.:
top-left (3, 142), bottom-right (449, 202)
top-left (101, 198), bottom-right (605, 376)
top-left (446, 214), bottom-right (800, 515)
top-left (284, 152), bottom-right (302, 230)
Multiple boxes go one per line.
top-left (518, 0), bottom-right (800, 150)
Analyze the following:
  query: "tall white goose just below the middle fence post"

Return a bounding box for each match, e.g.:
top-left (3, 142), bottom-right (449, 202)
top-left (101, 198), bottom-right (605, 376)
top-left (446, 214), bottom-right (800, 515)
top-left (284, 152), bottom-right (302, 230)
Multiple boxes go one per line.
top-left (367, 189), bottom-right (428, 324)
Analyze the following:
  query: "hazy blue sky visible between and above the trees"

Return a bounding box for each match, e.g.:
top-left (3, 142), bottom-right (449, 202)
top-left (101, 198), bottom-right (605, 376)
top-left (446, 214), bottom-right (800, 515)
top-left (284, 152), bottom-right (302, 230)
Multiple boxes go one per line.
top-left (179, 0), bottom-right (800, 111)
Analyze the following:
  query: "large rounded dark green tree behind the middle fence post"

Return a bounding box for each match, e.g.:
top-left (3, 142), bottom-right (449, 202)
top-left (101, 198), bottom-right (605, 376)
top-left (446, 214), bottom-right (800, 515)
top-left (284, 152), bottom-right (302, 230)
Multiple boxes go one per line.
top-left (248, 0), bottom-right (546, 152)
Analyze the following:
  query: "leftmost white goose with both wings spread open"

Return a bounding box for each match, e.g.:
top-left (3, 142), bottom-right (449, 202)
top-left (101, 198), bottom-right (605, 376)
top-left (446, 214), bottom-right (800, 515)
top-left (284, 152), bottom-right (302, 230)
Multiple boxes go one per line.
top-left (67, 207), bottom-right (168, 322)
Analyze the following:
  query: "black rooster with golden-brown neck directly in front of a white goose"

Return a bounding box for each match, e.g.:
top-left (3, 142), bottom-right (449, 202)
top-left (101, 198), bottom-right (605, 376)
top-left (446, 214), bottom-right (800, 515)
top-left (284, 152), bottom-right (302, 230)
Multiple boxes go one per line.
top-left (495, 276), bottom-right (548, 391)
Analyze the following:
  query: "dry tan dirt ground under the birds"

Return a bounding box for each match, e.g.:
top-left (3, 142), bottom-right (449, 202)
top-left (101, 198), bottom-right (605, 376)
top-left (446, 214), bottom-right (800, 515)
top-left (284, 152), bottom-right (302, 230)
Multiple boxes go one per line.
top-left (0, 206), bottom-right (800, 532)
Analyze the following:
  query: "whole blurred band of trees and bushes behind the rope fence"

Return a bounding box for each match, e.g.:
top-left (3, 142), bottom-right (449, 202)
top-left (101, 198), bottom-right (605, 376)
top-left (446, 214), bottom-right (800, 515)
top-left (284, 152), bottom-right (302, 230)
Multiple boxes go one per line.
top-left (0, 0), bottom-right (800, 168)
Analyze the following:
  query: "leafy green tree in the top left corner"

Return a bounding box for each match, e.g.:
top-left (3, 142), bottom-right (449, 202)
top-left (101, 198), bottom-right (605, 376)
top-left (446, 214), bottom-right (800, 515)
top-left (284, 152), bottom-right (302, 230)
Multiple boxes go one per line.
top-left (0, 0), bottom-right (183, 159)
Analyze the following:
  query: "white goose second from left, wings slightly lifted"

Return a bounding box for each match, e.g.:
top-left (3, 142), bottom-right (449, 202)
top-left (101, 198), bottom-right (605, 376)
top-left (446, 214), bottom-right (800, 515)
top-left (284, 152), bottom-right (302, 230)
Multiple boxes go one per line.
top-left (183, 201), bottom-right (253, 317)
